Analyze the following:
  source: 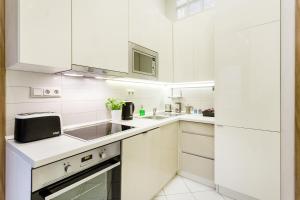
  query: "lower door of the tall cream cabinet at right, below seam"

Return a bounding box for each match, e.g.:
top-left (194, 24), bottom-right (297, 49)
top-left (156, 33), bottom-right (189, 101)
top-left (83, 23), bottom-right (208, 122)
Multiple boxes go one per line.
top-left (215, 126), bottom-right (280, 200)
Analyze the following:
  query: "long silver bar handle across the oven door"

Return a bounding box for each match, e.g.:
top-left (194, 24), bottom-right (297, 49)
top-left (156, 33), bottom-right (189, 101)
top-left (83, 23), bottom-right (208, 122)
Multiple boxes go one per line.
top-left (45, 162), bottom-right (121, 200)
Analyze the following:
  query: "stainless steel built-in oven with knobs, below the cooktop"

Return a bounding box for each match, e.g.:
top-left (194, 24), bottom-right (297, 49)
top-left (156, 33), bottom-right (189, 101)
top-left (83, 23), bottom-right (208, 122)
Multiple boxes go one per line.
top-left (31, 142), bottom-right (121, 200)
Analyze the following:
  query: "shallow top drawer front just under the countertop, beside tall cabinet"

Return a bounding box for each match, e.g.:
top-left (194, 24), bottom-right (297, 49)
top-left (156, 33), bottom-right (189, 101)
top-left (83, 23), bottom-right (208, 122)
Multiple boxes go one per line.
top-left (180, 122), bottom-right (214, 136)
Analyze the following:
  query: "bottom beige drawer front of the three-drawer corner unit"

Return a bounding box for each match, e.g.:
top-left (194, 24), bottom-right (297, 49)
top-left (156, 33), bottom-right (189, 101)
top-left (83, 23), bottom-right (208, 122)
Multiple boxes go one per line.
top-left (181, 153), bottom-right (214, 181)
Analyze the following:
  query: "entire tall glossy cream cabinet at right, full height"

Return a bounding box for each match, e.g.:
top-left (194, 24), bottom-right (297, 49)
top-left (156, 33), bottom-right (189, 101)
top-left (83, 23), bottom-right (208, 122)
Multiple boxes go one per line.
top-left (215, 0), bottom-right (280, 200)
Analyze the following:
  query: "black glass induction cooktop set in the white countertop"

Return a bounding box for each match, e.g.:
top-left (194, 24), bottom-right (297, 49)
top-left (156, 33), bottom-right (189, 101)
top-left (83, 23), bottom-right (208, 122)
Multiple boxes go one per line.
top-left (64, 122), bottom-right (134, 140)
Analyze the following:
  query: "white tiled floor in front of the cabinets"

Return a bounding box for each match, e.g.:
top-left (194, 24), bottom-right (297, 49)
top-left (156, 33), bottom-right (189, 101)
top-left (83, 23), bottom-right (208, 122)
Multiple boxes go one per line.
top-left (153, 176), bottom-right (236, 200)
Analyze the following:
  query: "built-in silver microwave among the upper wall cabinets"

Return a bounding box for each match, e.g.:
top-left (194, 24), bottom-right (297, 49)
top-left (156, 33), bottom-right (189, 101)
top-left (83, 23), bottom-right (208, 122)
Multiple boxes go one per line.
top-left (129, 42), bottom-right (158, 80)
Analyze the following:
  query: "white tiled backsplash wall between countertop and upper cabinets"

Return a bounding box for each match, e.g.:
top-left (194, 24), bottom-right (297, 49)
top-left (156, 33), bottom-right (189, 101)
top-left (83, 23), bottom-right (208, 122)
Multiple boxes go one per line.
top-left (6, 70), bottom-right (213, 135)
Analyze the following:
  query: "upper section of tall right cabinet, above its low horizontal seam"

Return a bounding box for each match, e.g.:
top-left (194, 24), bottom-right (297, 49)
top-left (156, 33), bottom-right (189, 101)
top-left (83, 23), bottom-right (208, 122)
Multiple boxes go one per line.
top-left (215, 0), bottom-right (280, 132)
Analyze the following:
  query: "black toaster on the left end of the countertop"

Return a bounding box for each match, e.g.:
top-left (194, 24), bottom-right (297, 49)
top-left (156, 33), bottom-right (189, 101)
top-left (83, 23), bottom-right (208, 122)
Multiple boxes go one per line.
top-left (15, 112), bottom-right (62, 143)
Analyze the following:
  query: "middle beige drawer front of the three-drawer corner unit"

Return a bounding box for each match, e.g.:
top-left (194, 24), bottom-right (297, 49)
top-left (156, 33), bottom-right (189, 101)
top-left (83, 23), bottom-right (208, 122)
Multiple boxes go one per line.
top-left (182, 133), bottom-right (214, 159)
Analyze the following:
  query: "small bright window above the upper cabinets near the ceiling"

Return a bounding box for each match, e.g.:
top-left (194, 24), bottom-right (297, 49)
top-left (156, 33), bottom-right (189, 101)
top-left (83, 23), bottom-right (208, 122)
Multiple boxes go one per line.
top-left (176, 0), bottom-right (216, 19)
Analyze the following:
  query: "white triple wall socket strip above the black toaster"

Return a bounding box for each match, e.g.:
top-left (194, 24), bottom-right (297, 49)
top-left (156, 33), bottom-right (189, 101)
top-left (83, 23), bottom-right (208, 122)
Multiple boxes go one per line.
top-left (30, 87), bottom-right (61, 98)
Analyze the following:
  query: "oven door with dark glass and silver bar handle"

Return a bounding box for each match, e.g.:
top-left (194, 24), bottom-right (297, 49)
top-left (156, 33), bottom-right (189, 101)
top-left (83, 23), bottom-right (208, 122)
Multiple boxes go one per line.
top-left (33, 162), bottom-right (120, 200)
